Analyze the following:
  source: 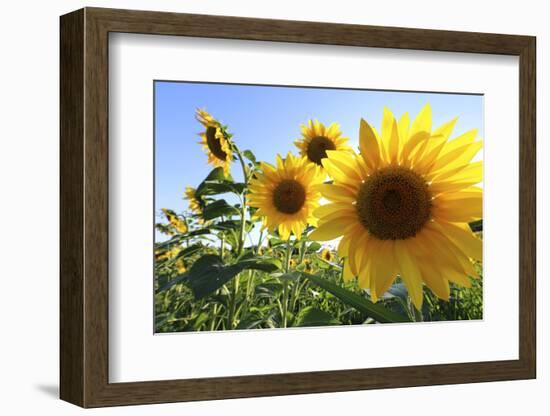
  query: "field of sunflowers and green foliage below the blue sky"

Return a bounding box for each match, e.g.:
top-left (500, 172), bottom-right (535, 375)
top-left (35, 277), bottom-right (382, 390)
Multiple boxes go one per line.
top-left (154, 105), bottom-right (483, 332)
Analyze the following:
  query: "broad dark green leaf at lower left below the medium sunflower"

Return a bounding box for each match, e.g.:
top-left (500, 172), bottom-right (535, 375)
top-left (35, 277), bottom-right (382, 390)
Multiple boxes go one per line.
top-left (187, 254), bottom-right (277, 299)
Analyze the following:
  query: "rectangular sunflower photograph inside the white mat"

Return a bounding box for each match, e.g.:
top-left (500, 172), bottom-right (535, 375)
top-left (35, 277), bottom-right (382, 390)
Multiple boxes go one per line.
top-left (154, 81), bottom-right (483, 333)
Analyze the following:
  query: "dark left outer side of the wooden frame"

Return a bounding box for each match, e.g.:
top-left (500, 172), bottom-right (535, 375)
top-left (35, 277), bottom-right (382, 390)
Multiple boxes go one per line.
top-left (59, 10), bottom-right (85, 406)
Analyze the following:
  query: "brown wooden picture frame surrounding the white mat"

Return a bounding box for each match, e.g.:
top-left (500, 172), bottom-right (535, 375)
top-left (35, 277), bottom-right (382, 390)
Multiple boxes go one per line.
top-left (60, 8), bottom-right (536, 407)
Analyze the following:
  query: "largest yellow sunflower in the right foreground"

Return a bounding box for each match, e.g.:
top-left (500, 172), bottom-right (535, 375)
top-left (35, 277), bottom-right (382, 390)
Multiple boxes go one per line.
top-left (310, 106), bottom-right (482, 309)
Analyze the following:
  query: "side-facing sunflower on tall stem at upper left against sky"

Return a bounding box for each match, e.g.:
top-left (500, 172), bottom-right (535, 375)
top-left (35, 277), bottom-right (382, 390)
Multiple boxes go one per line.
top-left (196, 109), bottom-right (233, 176)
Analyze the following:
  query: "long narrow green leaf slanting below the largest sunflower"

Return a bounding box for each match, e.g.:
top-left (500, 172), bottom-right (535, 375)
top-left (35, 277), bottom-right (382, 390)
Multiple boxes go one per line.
top-left (302, 273), bottom-right (410, 323)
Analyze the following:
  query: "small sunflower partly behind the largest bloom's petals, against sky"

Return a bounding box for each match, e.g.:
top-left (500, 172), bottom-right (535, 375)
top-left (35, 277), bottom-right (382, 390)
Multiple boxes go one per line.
top-left (294, 120), bottom-right (352, 166)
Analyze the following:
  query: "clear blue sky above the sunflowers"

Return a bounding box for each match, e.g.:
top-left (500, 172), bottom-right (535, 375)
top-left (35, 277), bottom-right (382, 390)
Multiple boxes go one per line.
top-left (154, 81), bottom-right (483, 239)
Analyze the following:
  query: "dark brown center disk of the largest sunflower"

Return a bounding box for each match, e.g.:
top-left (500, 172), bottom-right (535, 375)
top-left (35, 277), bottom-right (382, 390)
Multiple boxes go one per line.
top-left (356, 167), bottom-right (432, 240)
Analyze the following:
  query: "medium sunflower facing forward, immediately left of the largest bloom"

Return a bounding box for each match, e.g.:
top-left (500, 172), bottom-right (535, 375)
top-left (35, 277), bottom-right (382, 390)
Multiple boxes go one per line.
top-left (248, 152), bottom-right (324, 240)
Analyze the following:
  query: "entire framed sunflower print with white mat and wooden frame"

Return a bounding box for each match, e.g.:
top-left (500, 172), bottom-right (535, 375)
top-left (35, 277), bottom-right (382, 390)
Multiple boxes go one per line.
top-left (60, 8), bottom-right (536, 407)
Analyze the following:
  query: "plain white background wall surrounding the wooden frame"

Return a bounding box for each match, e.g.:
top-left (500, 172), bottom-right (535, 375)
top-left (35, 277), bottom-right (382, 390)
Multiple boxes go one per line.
top-left (0, 0), bottom-right (550, 416)
